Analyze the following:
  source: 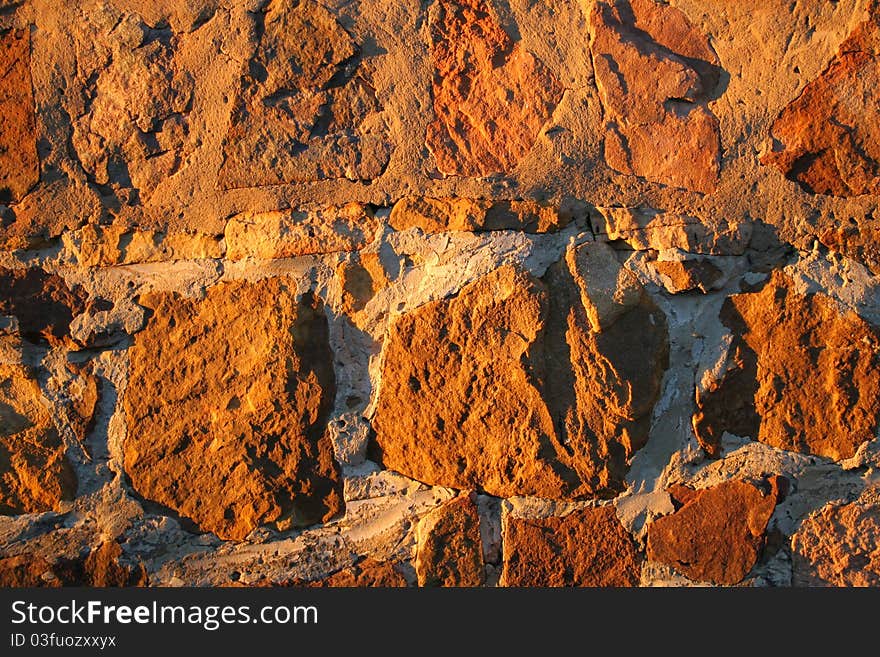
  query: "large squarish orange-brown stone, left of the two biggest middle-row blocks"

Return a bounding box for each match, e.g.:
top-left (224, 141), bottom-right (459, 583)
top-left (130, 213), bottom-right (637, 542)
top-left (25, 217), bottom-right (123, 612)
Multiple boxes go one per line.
top-left (125, 278), bottom-right (342, 539)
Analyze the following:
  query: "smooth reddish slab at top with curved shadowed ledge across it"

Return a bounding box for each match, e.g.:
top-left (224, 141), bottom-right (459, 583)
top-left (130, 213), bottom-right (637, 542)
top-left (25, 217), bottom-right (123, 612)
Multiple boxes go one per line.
top-left (590, 0), bottom-right (721, 193)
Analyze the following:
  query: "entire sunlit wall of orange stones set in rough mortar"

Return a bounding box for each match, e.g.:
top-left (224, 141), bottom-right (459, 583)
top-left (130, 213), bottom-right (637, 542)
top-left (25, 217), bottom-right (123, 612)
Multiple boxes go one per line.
top-left (0, 0), bottom-right (880, 586)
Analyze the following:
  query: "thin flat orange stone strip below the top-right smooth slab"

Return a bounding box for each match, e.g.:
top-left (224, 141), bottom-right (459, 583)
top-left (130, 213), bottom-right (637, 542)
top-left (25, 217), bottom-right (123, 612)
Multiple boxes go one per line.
top-left (591, 206), bottom-right (753, 255)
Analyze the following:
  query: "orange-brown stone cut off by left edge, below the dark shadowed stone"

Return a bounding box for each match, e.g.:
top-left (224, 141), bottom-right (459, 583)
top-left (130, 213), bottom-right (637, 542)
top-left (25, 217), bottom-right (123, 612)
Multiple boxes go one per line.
top-left (0, 364), bottom-right (76, 515)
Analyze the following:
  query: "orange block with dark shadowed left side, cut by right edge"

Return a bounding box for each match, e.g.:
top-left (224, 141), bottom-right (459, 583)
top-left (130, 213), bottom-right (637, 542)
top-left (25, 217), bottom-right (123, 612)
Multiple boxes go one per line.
top-left (693, 271), bottom-right (880, 460)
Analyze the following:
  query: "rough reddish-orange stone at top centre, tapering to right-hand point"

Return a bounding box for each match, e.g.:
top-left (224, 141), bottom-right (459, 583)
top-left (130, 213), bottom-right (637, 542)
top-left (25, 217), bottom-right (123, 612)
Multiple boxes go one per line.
top-left (425, 0), bottom-right (563, 176)
